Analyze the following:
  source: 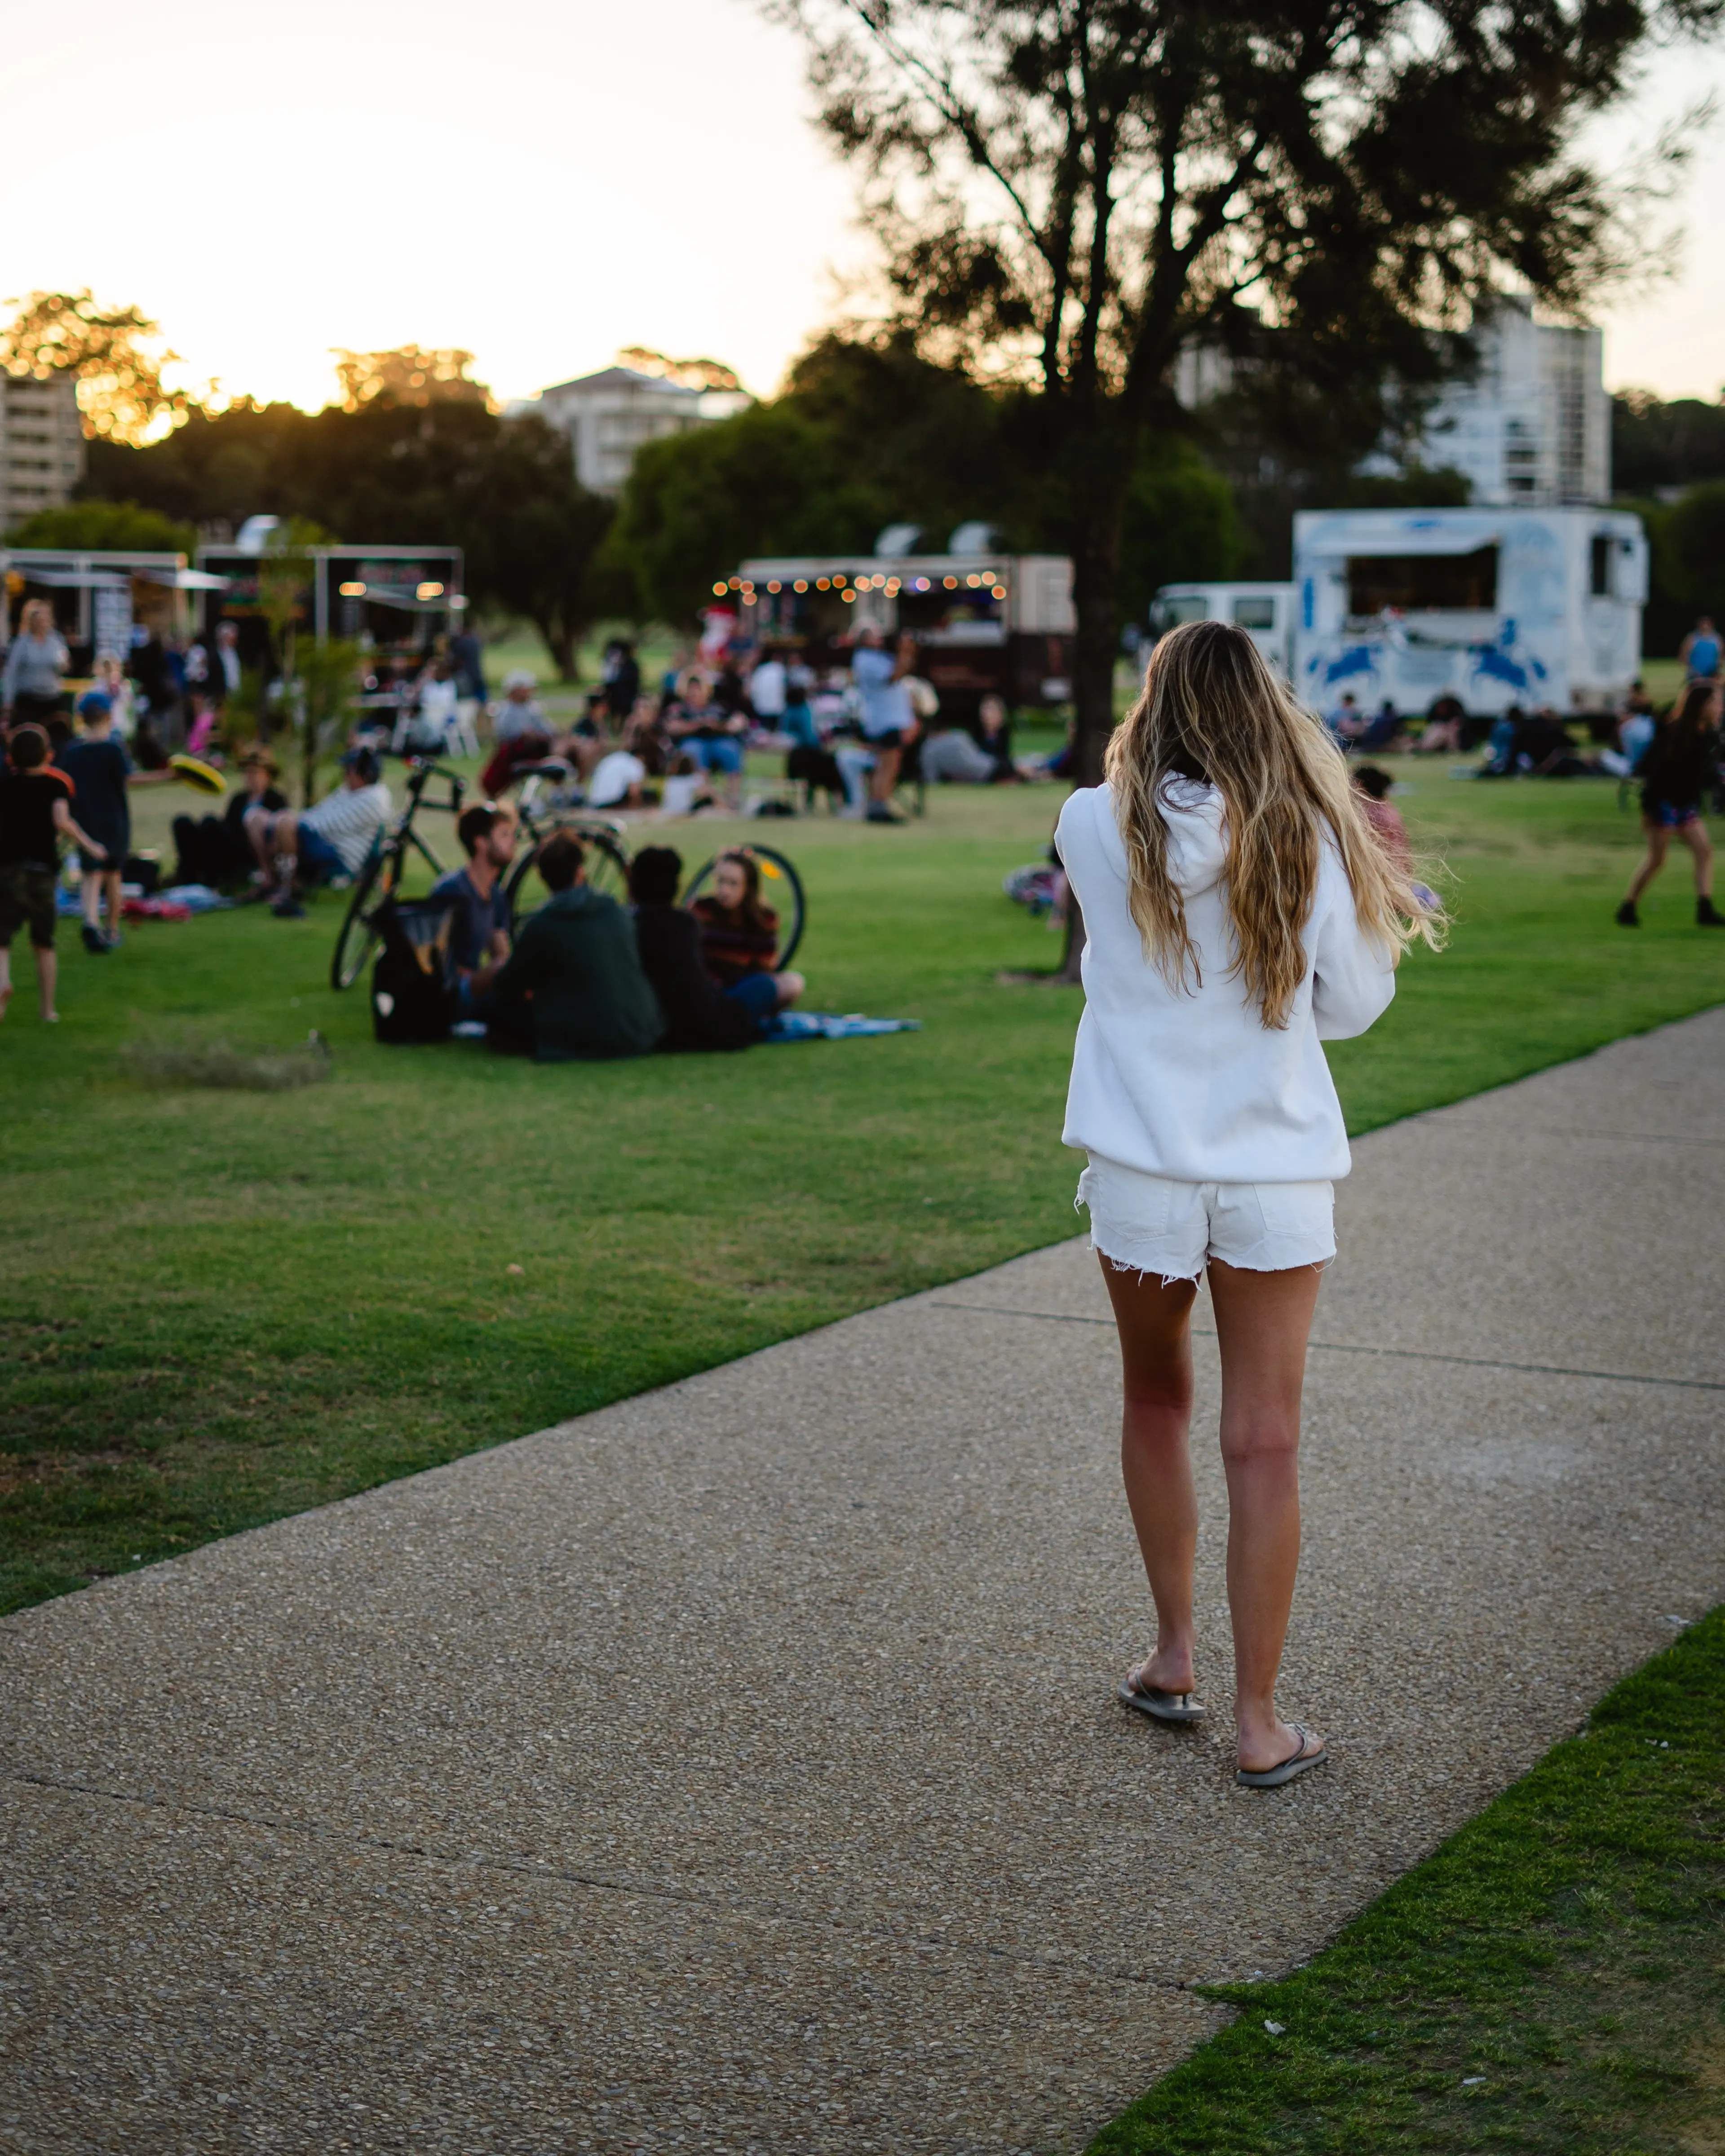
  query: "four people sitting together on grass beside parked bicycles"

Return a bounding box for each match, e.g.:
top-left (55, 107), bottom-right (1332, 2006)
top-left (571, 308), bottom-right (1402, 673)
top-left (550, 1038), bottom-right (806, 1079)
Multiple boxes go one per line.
top-left (431, 804), bottom-right (802, 1063)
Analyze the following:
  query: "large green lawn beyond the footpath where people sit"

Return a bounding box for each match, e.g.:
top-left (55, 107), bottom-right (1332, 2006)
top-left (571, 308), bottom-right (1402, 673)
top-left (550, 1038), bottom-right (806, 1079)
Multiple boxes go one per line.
top-left (0, 768), bottom-right (1725, 1608)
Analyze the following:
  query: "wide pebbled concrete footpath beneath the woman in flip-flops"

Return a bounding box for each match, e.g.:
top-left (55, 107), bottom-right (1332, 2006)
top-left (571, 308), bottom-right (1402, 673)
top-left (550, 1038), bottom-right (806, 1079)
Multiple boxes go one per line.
top-left (0, 1011), bottom-right (1725, 2156)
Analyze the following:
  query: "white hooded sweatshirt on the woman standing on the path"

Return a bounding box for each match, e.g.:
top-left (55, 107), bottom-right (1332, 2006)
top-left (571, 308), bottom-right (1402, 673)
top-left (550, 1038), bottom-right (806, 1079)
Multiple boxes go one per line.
top-left (1054, 781), bottom-right (1395, 1184)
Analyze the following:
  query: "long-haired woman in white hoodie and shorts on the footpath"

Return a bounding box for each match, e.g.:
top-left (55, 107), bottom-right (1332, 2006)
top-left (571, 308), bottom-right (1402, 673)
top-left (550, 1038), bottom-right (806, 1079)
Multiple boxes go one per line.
top-left (1054, 621), bottom-right (1445, 1789)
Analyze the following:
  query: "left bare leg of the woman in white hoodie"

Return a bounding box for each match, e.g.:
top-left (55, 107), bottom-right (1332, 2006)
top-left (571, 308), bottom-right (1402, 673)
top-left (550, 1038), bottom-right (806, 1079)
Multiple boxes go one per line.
top-left (1102, 1257), bottom-right (1199, 1692)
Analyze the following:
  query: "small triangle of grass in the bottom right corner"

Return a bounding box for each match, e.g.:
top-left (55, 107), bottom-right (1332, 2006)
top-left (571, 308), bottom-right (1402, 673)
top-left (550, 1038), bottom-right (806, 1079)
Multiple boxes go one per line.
top-left (1091, 1611), bottom-right (1725, 2156)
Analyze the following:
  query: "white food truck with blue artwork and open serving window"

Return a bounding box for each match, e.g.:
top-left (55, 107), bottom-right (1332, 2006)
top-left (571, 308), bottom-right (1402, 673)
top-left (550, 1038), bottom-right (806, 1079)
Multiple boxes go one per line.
top-left (1294, 509), bottom-right (1647, 716)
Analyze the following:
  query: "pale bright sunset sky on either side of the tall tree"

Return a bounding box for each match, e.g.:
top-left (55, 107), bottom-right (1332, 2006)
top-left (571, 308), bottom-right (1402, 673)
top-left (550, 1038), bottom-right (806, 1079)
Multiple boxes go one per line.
top-left (0, 0), bottom-right (1725, 407)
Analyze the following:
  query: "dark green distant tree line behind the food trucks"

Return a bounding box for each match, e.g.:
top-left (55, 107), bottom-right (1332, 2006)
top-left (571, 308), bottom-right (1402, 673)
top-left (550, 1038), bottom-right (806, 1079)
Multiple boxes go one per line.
top-left (34, 296), bottom-right (1725, 677)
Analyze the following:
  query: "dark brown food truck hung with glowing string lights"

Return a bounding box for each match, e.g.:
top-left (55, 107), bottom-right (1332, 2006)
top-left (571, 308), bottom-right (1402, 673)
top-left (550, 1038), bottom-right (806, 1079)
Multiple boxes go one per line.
top-left (733, 552), bottom-right (1076, 718)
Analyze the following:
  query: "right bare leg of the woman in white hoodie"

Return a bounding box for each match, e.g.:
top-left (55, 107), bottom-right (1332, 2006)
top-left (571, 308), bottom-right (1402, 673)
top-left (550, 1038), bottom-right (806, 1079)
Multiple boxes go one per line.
top-left (1210, 1259), bottom-right (1322, 1770)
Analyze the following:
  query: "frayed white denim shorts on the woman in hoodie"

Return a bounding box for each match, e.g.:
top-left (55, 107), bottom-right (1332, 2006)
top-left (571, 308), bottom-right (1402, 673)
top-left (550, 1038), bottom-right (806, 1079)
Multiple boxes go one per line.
top-left (1074, 1160), bottom-right (1335, 1285)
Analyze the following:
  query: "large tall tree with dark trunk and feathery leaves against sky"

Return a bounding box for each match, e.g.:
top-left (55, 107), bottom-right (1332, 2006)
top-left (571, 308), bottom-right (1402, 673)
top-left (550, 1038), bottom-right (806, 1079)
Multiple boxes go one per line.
top-left (763, 0), bottom-right (1725, 778)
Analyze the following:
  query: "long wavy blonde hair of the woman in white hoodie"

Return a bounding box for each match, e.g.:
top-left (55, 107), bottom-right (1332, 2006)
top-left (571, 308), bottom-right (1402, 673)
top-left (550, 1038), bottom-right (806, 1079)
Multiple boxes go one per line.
top-left (1106, 621), bottom-right (1445, 1029)
